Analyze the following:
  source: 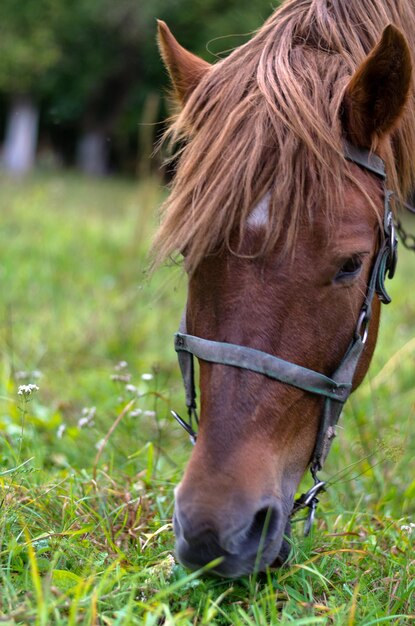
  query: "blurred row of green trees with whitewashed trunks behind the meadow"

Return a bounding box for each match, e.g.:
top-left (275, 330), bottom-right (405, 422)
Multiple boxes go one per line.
top-left (0, 0), bottom-right (278, 174)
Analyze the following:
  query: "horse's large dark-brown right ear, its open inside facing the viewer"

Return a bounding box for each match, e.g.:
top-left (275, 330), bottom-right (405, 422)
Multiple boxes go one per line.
top-left (342, 24), bottom-right (412, 148)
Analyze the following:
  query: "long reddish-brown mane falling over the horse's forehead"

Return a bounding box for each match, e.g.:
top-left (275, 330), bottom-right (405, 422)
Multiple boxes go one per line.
top-left (154, 0), bottom-right (415, 271)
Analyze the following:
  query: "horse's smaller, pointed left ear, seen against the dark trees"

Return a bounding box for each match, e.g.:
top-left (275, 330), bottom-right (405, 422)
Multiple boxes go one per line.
top-left (157, 20), bottom-right (211, 104)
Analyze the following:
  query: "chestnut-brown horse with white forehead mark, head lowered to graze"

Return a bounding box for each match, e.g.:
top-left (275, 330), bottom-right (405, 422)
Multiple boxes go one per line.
top-left (155, 0), bottom-right (415, 576)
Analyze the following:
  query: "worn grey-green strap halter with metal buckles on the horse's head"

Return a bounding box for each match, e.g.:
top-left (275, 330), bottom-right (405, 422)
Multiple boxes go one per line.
top-left (172, 142), bottom-right (398, 535)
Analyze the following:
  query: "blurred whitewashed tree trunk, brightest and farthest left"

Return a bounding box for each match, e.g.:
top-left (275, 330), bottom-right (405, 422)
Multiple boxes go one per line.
top-left (3, 96), bottom-right (39, 175)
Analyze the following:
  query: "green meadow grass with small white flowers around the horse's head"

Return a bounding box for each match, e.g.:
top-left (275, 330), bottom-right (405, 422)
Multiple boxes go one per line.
top-left (0, 174), bottom-right (415, 626)
